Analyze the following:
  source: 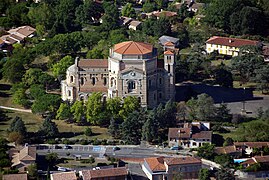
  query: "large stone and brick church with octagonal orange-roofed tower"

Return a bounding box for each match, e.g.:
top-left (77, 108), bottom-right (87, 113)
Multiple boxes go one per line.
top-left (61, 41), bottom-right (175, 107)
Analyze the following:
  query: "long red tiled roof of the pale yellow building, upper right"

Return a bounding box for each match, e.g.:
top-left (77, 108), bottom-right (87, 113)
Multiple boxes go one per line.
top-left (206, 36), bottom-right (258, 47)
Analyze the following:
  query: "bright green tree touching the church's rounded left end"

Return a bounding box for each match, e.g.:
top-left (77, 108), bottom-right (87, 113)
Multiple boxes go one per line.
top-left (52, 56), bottom-right (74, 81)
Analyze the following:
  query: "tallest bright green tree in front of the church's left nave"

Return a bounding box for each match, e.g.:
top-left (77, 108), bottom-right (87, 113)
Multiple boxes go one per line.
top-left (86, 92), bottom-right (109, 125)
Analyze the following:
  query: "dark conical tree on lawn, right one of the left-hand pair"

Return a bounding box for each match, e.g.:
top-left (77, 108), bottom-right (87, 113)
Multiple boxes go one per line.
top-left (39, 116), bottom-right (59, 138)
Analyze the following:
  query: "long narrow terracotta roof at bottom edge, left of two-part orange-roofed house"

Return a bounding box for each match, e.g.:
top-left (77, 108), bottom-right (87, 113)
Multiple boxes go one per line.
top-left (82, 167), bottom-right (128, 180)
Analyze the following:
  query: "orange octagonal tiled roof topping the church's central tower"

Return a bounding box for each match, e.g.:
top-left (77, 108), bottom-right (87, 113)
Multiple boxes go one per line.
top-left (114, 41), bottom-right (153, 55)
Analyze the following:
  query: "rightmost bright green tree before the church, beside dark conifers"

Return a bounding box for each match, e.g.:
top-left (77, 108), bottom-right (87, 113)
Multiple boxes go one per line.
top-left (119, 96), bottom-right (140, 120)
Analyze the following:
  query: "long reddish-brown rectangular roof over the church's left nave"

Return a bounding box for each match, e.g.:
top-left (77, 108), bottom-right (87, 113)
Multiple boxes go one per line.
top-left (78, 59), bottom-right (108, 68)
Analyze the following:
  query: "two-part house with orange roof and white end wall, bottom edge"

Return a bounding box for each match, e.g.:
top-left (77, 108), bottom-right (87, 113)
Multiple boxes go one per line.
top-left (142, 157), bottom-right (202, 180)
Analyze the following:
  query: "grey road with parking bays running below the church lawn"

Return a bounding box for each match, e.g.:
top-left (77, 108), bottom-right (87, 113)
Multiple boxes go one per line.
top-left (37, 145), bottom-right (191, 158)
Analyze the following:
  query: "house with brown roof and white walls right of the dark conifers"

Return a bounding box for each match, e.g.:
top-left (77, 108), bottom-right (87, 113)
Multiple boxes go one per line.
top-left (168, 122), bottom-right (212, 148)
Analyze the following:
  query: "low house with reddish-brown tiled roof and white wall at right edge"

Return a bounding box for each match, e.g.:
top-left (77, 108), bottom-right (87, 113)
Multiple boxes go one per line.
top-left (234, 142), bottom-right (269, 155)
